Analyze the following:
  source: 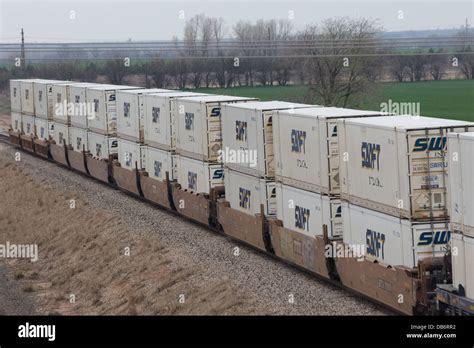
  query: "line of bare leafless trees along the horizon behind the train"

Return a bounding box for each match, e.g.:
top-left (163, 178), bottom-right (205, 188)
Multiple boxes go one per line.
top-left (0, 14), bottom-right (474, 107)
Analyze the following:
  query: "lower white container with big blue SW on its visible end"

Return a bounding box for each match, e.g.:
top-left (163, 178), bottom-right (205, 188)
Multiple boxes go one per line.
top-left (342, 201), bottom-right (451, 268)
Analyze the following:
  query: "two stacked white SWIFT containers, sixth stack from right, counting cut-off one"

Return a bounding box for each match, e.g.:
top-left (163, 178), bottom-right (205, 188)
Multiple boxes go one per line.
top-left (143, 91), bottom-right (205, 182)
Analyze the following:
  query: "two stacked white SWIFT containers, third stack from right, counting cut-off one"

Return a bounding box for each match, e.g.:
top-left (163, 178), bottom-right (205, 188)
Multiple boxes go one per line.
top-left (273, 107), bottom-right (388, 239)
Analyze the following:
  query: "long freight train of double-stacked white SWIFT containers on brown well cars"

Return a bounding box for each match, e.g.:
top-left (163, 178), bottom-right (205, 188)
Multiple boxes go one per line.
top-left (9, 80), bottom-right (474, 315)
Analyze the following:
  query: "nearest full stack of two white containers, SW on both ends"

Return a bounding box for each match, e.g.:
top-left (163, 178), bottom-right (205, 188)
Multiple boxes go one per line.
top-left (337, 116), bottom-right (474, 268)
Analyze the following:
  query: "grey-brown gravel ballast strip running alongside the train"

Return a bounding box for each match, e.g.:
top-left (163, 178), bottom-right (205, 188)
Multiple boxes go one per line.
top-left (0, 143), bottom-right (390, 315)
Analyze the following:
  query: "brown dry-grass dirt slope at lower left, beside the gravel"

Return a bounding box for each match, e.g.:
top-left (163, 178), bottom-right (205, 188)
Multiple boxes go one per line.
top-left (0, 158), bottom-right (262, 315)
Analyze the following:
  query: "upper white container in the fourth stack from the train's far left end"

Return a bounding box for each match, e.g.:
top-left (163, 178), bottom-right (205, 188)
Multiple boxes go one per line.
top-left (51, 81), bottom-right (99, 125)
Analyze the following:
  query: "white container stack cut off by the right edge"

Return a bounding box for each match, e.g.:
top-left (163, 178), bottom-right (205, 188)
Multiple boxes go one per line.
top-left (448, 133), bottom-right (474, 300)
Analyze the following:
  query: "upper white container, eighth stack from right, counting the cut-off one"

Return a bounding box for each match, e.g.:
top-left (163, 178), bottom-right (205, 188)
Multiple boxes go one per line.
top-left (86, 85), bottom-right (141, 135)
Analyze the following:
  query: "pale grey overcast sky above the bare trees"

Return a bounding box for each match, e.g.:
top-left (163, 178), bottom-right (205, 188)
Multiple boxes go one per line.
top-left (0, 0), bottom-right (473, 43)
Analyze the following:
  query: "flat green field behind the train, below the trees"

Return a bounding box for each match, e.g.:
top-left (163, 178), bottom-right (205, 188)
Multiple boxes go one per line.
top-left (194, 80), bottom-right (474, 122)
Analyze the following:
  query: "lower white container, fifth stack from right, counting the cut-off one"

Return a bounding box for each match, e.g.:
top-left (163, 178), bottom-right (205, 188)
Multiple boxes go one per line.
top-left (176, 155), bottom-right (224, 194)
